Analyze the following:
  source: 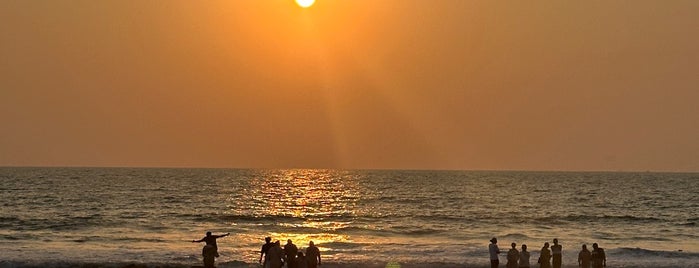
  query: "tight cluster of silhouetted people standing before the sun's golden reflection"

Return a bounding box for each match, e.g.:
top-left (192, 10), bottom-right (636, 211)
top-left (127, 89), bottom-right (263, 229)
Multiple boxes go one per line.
top-left (260, 237), bottom-right (321, 268)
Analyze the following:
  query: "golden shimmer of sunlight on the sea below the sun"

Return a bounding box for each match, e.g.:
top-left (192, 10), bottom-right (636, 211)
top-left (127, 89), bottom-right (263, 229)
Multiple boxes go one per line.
top-left (228, 170), bottom-right (360, 256)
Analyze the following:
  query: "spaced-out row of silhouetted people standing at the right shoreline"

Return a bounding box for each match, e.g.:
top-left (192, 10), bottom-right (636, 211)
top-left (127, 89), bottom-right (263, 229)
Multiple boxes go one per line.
top-left (488, 237), bottom-right (607, 268)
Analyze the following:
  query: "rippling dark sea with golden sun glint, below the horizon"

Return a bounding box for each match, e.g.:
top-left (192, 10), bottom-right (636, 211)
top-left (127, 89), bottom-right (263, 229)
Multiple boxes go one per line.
top-left (0, 168), bottom-right (699, 268)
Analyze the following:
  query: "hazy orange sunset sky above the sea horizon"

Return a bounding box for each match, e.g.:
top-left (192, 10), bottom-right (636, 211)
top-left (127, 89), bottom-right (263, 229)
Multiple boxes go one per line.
top-left (0, 0), bottom-right (699, 172)
